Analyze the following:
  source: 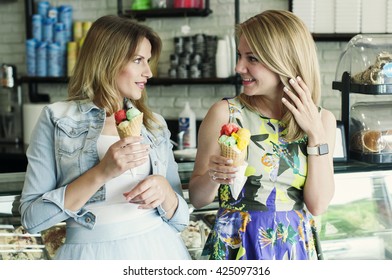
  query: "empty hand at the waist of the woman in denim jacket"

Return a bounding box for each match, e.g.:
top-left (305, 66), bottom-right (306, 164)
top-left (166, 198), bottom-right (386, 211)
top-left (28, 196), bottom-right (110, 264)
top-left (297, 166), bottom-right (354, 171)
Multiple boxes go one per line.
top-left (123, 175), bottom-right (174, 209)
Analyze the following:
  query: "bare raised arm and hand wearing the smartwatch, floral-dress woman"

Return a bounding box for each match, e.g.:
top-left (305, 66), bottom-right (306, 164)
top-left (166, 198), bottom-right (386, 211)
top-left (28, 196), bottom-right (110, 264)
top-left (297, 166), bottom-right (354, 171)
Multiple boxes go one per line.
top-left (282, 77), bottom-right (336, 216)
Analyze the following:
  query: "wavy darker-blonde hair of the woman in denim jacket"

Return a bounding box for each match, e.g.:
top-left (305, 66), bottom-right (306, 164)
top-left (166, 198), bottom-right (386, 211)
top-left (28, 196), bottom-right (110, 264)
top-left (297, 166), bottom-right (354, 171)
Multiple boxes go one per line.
top-left (68, 15), bottom-right (162, 130)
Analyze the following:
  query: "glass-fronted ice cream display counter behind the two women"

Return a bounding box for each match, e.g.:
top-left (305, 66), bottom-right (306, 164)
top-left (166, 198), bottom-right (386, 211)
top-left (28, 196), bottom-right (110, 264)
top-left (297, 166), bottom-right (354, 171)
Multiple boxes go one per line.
top-left (0, 162), bottom-right (392, 260)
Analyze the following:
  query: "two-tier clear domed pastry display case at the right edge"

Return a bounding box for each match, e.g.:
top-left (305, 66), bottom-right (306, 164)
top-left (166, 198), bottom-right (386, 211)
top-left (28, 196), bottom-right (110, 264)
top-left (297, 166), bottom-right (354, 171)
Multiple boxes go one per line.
top-left (332, 34), bottom-right (392, 164)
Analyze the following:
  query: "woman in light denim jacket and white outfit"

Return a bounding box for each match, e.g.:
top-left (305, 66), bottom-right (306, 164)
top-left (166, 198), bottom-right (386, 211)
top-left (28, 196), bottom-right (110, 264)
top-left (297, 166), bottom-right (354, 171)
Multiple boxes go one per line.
top-left (20, 16), bottom-right (190, 260)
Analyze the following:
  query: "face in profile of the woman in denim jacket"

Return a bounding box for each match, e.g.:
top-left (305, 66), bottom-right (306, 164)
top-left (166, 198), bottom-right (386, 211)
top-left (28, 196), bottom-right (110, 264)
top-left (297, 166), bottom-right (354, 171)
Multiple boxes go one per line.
top-left (116, 38), bottom-right (152, 100)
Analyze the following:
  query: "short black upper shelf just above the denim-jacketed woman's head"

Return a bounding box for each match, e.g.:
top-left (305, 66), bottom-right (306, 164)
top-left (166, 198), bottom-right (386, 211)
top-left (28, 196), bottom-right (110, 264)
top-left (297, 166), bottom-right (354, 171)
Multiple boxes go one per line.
top-left (120, 8), bottom-right (212, 20)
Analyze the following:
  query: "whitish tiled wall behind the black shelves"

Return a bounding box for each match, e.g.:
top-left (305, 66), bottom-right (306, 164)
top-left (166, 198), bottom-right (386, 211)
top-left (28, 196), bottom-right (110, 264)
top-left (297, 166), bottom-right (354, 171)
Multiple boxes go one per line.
top-left (0, 0), bottom-right (356, 119)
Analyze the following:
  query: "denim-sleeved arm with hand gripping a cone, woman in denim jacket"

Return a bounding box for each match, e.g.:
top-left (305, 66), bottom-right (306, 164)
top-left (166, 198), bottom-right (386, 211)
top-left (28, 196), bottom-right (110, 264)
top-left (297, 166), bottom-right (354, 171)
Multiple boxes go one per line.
top-left (19, 108), bottom-right (148, 233)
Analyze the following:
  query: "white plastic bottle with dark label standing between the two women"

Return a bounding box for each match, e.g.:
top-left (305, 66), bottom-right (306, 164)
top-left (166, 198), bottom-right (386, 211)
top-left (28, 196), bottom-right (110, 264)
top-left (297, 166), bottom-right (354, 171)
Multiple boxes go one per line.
top-left (178, 102), bottom-right (196, 149)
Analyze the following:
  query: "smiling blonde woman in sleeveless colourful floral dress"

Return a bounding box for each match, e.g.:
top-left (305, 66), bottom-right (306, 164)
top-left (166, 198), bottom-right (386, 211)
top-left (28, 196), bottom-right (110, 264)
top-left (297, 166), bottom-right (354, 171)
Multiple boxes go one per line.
top-left (189, 10), bottom-right (336, 259)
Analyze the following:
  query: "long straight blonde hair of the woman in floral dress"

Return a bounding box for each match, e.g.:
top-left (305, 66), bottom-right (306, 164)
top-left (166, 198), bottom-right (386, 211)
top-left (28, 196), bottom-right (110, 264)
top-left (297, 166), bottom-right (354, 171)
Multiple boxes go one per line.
top-left (236, 10), bottom-right (321, 141)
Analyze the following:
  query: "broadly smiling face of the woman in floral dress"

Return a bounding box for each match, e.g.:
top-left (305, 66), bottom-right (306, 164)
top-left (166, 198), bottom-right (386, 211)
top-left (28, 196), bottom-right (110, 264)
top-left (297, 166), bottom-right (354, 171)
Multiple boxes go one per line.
top-left (235, 36), bottom-right (282, 97)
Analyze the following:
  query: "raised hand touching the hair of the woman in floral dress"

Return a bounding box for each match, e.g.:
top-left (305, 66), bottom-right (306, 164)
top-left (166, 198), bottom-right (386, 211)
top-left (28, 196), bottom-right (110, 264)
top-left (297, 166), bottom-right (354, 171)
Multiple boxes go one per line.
top-left (282, 77), bottom-right (323, 134)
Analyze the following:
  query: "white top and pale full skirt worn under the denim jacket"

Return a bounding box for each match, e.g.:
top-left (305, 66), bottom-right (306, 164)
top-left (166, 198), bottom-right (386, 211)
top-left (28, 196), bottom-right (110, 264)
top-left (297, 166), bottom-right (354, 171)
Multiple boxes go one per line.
top-left (56, 135), bottom-right (190, 260)
